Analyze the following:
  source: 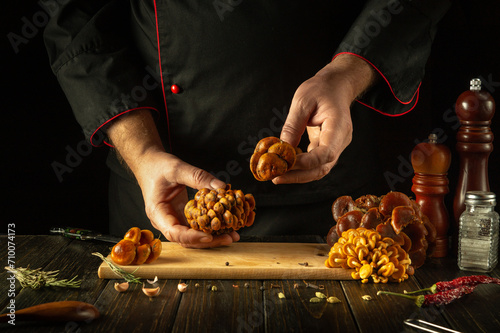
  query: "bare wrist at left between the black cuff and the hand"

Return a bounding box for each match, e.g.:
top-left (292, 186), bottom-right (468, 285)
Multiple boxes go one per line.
top-left (107, 109), bottom-right (165, 177)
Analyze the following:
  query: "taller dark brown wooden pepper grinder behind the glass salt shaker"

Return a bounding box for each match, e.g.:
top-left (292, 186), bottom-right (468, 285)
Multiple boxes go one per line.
top-left (453, 79), bottom-right (495, 251)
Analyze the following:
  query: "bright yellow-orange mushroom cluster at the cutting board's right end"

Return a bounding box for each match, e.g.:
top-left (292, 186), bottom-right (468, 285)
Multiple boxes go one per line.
top-left (325, 228), bottom-right (414, 283)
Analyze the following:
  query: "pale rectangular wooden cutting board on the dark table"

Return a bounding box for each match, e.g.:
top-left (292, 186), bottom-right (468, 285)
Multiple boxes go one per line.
top-left (98, 242), bottom-right (352, 280)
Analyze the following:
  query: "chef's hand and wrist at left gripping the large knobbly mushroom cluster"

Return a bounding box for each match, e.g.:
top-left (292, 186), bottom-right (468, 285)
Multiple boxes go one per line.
top-left (108, 110), bottom-right (239, 248)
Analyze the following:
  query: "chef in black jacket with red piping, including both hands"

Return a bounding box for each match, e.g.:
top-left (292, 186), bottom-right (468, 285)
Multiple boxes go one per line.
top-left (45, 0), bottom-right (449, 247)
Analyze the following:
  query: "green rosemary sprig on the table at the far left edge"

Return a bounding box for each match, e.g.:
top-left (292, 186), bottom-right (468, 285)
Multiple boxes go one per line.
top-left (5, 267), bottom-right (82, 289)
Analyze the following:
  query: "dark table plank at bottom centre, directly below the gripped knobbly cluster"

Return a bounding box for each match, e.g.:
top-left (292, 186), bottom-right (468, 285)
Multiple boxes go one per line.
top-left (172, 280), bottom-right (265, 333)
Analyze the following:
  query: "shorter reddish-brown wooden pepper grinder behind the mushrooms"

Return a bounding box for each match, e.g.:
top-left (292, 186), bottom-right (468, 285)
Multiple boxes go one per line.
top-left (411, 134), bottom-right (451, 258)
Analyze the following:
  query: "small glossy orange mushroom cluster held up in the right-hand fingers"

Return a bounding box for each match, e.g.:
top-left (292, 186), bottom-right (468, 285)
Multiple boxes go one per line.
top-left (250, 136), bottom-right (302, 181)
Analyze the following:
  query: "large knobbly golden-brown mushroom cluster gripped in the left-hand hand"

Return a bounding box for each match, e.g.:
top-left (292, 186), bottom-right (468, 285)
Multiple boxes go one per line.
top-left (184, 184), bottom-right (255, 235)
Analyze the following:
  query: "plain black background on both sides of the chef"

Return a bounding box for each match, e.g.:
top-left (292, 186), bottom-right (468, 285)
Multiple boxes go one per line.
top-left (0, 0), bottom-right (500, 234)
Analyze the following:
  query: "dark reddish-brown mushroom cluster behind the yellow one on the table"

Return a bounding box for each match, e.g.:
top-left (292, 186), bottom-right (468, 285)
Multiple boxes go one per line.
top-left (327, 192), bottom-right (436, 268)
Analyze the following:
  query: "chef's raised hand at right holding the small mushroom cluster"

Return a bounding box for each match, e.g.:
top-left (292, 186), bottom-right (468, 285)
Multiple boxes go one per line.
top-left (273, 54), bottom-right (375, 184)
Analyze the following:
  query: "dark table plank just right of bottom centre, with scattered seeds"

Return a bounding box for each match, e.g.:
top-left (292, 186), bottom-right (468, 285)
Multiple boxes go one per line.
top-left (264, 280), bottom-right (358, 332)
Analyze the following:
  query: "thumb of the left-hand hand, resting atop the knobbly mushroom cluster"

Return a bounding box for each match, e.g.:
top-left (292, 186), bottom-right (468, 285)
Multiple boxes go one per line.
top-left (176, 162), bottom-right (226, 190)
